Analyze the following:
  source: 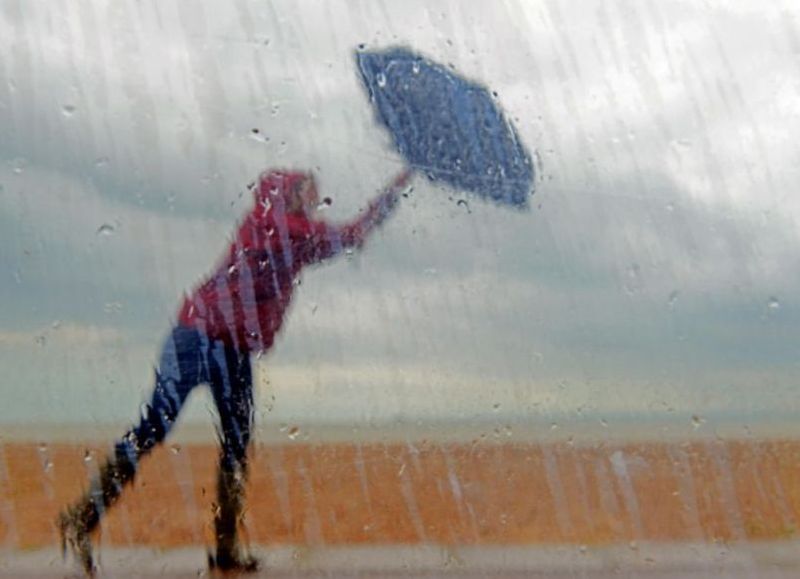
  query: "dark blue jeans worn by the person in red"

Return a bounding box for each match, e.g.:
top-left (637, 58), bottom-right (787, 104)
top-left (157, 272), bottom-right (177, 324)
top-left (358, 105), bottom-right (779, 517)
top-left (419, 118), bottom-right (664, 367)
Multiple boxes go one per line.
top-left (116, 325), bottom-right (253, 470)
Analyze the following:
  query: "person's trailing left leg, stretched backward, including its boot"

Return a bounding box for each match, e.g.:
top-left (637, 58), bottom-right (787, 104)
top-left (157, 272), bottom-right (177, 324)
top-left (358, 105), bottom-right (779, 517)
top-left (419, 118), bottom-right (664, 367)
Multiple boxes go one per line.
top-left (57, 327), bottom-right (206, 573)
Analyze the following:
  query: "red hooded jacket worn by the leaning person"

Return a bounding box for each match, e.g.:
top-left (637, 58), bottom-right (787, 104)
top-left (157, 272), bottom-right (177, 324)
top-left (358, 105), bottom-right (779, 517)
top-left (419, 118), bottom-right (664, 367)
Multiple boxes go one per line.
top-left (178, 171), bottom-right (397, 352)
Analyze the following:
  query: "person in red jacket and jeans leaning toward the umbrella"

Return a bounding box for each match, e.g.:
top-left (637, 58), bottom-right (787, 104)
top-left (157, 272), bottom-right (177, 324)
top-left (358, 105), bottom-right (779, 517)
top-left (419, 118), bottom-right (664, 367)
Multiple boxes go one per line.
top-left (56, 171), bottom-right (411, 575)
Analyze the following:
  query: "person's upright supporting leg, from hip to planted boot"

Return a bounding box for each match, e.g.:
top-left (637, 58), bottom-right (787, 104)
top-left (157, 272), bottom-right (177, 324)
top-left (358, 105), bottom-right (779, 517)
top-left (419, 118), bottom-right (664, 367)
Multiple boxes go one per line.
top-left (209, 344), bottom-right (258, 571)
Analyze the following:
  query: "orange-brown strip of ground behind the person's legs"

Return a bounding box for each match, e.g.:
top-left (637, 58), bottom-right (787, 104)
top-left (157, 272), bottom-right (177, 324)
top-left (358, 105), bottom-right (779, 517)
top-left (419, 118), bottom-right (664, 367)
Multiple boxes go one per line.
top-left (0, 432), bottom-right (800, 551)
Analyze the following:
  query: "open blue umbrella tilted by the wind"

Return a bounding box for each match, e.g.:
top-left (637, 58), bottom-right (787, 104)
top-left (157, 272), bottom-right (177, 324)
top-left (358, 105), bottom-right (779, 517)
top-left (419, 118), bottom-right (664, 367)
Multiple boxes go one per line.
top-left (356, 48), bottom-right (534, 208)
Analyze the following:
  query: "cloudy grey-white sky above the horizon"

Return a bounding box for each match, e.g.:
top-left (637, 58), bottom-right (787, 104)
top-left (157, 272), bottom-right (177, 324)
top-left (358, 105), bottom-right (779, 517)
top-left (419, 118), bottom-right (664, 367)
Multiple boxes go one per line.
top-left (0, 0), bottom-right (800, 424)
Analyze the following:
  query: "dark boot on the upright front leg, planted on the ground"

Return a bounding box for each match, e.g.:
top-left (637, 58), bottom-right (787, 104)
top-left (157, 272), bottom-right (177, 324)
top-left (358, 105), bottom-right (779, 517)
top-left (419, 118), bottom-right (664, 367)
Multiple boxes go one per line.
top-left (209, 461), bottom-right (260, 573)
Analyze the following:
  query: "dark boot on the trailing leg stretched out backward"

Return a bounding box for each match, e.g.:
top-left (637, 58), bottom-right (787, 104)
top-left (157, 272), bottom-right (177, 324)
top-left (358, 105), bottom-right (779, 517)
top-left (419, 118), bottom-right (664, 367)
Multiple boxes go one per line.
top-left (56, 458), bottom-right (136, 576)
